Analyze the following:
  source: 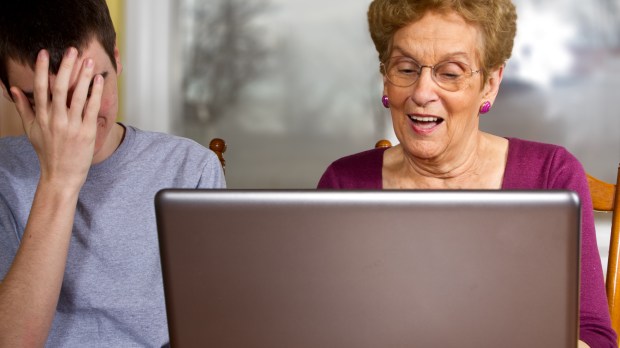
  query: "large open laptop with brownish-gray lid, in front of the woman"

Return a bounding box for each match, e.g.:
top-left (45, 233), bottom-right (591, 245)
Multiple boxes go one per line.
top-left (155, 189), bottom-right (580, 348)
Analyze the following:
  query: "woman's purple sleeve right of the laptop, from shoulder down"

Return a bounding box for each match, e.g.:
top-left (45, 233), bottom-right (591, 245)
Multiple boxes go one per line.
top-left (547, 148), bottom-right (617, 348)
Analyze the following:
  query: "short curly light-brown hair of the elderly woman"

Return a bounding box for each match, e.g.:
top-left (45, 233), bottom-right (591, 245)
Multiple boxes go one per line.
top-left (368, 0), bottom-right (517, 79)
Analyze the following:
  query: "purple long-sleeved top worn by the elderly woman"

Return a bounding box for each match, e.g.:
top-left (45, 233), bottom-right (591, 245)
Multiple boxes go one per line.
top-left (318, 138), bottom-right (617, 348)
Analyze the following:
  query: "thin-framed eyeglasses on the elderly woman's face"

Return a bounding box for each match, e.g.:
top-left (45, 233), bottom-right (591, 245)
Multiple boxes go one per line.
top-left (381, 57), bottom-right (480, 92)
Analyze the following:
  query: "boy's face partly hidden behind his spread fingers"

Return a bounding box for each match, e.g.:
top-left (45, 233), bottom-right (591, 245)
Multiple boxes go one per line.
top-left (5, 38), bottom-right (122, 163)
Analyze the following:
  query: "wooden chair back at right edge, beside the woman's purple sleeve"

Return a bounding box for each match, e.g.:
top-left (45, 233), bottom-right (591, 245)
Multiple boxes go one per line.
top-left (588, 165), bottom-right (620, 342)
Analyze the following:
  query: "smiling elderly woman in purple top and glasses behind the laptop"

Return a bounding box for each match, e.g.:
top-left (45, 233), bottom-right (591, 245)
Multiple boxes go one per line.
top-left (318, 0), bottom-right (616, 347)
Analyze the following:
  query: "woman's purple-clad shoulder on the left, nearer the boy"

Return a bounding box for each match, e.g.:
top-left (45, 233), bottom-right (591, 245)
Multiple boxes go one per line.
top-left (318, 148), bottom-right (385, 189)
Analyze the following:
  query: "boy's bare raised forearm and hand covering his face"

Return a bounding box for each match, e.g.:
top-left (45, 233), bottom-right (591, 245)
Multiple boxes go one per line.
top-left (0, 48), bottom-right (103, 347)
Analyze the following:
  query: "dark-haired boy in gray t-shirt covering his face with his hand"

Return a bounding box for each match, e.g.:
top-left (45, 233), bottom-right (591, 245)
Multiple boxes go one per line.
top-left (0, 0), bottom-right (225, 347)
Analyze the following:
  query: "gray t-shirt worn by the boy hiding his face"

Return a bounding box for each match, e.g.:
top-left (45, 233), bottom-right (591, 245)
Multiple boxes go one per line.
top-left (0, 126), bottom-right (225, 347)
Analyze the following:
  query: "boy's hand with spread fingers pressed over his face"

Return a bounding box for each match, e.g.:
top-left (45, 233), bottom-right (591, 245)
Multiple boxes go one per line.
top-left (11, 48), bottom-right (103, 191)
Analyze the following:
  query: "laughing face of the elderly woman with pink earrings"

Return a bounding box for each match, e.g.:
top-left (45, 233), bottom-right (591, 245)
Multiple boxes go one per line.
top-left (384, 12), bottom-right (502, 161)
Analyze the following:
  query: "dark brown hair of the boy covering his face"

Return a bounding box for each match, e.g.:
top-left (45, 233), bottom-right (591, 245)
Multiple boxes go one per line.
top-left (0, 0), bottom-right (117, 88)
